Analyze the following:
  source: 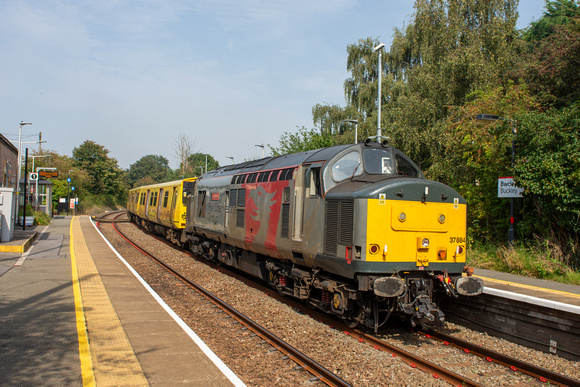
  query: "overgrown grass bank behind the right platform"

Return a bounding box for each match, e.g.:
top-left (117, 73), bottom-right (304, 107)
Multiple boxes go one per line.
top-left (467, 242), bottom-right (580, 285)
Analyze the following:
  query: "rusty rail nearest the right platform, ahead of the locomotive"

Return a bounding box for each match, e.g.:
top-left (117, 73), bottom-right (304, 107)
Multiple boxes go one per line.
top-left (418, 331), bottom-right (580, 386)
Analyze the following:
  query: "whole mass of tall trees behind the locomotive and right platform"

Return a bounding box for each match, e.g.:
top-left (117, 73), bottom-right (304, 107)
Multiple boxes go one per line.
top-left (274, 0), bottom-right (580, 267)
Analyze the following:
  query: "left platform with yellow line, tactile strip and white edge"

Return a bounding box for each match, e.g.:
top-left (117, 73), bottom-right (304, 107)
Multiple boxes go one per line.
top-left (0, 217), bottom-right (243, 386)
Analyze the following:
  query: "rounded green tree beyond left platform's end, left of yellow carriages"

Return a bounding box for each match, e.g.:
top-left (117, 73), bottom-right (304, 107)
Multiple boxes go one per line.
top-left (72, 140), bottom-right (127, 204)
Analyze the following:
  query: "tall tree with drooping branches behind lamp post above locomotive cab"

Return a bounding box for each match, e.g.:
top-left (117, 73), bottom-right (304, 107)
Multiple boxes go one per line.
top-left (313, 0), bottom-right (521, 168)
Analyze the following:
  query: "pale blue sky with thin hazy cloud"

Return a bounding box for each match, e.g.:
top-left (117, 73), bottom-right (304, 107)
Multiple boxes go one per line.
top-left (0, 0), bottom-right (545, 169)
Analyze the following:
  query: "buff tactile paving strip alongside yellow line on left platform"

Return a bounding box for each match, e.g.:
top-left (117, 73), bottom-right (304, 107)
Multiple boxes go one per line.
top-left (70, 216), bottom-right (149, 386)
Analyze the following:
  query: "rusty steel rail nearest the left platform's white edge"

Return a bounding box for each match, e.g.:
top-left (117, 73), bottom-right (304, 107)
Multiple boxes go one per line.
top-left (103, 215), bottom-right (351, 387)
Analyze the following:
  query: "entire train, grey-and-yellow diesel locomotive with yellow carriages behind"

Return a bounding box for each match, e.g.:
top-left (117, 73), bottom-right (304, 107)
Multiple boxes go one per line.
top-left (128, 140), bottom-right (483, 331)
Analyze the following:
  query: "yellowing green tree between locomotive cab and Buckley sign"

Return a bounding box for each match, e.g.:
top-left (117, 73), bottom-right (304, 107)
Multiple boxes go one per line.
top-left (426, 84), bottom-right (538, 241)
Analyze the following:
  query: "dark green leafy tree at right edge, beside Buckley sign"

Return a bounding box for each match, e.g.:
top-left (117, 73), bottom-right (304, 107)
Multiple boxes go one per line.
top-left (514, 103), bottom-right (580, 268)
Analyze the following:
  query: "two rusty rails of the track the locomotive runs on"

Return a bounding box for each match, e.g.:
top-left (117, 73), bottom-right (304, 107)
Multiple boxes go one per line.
top-left (97, 212), bottom-right (579, 386)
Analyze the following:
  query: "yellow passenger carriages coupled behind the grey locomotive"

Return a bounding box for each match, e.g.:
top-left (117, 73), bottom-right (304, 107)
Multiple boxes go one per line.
top-left (127, 177), bottom-right (197, 245)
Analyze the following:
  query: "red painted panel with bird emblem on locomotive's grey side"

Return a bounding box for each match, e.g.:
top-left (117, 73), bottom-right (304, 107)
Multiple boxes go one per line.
top-left (245, 181), bottom-right (288, 257)
